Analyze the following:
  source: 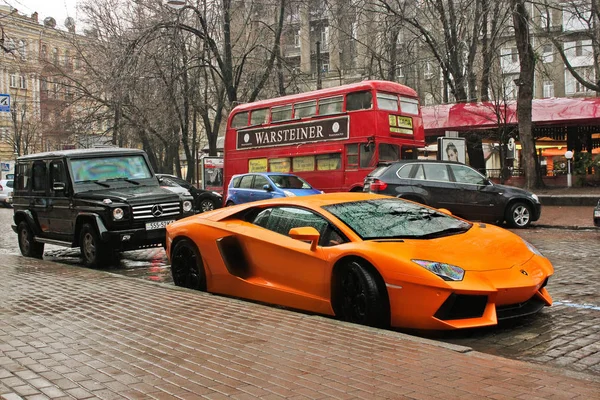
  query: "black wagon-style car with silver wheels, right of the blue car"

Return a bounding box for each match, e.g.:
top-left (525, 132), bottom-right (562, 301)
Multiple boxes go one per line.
top-left (363, 160), bottom-right (542, 228)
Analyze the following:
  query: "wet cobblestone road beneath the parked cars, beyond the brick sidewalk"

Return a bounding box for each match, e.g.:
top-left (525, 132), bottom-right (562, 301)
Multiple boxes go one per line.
top-left (0, 210), bottom-right (600, 377)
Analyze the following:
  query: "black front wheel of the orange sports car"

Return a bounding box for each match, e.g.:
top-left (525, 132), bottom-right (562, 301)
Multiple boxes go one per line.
top-left (334, 261), bottom-right (390, 328)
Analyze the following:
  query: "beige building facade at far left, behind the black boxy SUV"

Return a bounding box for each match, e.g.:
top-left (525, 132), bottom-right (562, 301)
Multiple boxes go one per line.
top-left (0, 5), bottom-right (85, 172)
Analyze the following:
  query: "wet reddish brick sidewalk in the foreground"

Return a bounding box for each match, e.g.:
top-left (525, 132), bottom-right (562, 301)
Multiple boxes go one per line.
top-left (0, 256), bottom-right (600, 400)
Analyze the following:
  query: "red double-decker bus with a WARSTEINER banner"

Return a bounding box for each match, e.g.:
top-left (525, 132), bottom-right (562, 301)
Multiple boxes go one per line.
top-left (224, 81), bottom-right (425, 192)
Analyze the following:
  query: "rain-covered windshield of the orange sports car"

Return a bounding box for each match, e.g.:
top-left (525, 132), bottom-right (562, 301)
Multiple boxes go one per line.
top-left (323, 198), bottom-right (471, 240)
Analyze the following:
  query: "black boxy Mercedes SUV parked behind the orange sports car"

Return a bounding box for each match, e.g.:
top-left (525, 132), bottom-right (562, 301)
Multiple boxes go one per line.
top-left (12, 148), bottom-right (194, 267)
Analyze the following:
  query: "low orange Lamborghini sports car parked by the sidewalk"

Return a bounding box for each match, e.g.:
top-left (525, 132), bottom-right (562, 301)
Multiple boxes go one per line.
top-left (167, 193), bottom-right (554, 329)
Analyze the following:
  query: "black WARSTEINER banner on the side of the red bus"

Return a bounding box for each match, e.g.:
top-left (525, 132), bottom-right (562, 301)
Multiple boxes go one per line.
top-left (237, 115), bottom-right (349, 150)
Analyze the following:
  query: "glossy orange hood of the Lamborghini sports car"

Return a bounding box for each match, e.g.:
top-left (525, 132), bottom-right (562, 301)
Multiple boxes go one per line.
top-left (370, 224), bottom-right (533, 271)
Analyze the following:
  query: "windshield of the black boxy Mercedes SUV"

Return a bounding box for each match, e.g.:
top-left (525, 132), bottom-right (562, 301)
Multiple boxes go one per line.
top-left (70, 155), bottom-right (152, 183)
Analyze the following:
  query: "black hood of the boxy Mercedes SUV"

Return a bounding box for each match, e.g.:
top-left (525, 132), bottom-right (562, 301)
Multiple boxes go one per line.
top-left (75, 186), bottom-right (180, 205)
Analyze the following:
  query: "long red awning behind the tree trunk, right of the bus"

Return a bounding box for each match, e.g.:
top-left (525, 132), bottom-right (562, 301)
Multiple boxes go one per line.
top-left (422, 98), bottom-right (600, 136)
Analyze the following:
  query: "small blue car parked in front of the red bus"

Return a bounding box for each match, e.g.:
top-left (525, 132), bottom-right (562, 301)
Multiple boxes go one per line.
top-left (225, 172), bottom-right (323, 206)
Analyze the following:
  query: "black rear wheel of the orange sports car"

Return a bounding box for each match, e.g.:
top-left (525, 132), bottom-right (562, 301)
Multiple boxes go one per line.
top-left (171, 239), bottom-right (206, 291)
